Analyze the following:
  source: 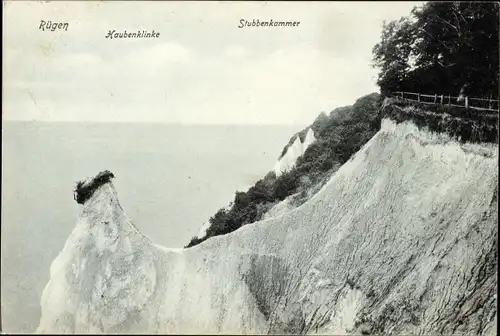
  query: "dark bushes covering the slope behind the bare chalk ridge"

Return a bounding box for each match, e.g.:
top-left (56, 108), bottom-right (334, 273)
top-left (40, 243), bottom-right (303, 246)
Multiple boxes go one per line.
top-left (186, 93), bottom-right (381, 247)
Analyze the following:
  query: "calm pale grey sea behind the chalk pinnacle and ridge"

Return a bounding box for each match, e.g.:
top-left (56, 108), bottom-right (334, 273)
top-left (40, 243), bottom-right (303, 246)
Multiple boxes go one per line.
top-left (1, 121), bottom-right (304, 333)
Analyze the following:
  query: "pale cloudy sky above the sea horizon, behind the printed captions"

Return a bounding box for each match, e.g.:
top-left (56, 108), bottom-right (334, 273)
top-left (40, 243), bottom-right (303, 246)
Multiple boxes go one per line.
top-left (2, 1), bottom-right (422, 125)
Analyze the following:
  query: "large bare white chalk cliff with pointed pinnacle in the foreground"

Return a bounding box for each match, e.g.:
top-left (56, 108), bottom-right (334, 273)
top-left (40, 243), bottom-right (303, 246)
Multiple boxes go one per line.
top-left (37, 119), bottom-right (498, 335)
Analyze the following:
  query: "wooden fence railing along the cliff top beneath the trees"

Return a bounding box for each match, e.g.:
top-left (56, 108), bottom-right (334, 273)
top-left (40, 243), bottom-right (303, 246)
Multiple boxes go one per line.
top-left (392, 91), bottom-right (500, 112)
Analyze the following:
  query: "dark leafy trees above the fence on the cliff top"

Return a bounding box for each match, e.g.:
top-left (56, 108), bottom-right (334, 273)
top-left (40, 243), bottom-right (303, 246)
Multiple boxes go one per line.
top-left (373, 1), bottom-right (499, 98)
